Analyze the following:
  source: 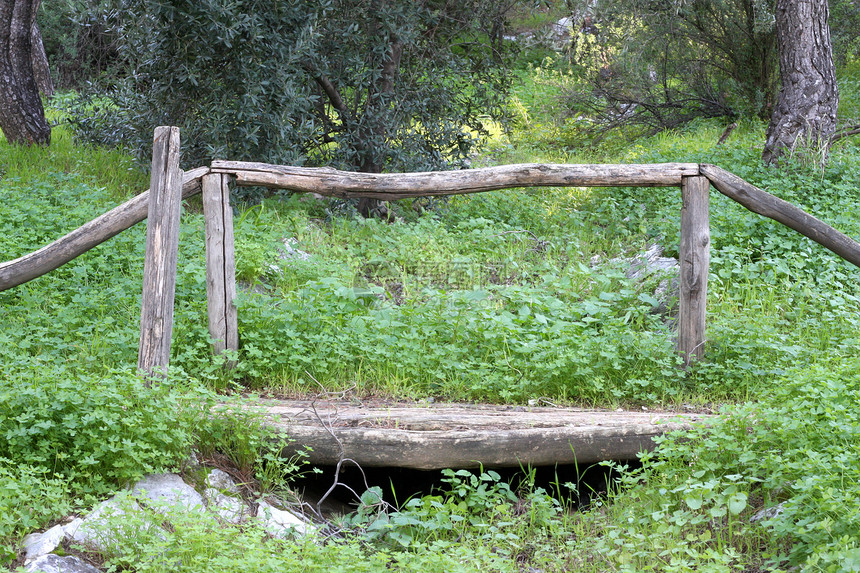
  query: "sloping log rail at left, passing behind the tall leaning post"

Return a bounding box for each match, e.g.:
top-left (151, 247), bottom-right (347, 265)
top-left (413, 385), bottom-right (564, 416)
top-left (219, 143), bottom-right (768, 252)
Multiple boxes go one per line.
top-left (0, 167), bottom-right (209, 291)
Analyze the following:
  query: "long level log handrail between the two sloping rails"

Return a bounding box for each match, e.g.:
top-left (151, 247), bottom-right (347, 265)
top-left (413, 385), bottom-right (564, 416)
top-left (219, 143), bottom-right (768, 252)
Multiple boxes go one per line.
top-left (212, 161), bottom-right (699, 200)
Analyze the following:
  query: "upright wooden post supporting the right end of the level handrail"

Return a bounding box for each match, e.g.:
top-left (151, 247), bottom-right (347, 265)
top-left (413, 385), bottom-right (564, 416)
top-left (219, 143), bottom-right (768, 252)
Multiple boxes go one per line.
top-left (678, 176), bottom-right (711, 368)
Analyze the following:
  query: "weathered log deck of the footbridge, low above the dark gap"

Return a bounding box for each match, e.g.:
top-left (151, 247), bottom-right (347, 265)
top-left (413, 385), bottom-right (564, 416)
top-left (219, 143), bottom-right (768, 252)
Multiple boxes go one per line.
top-left (262, 400), bottom-right (707, 470)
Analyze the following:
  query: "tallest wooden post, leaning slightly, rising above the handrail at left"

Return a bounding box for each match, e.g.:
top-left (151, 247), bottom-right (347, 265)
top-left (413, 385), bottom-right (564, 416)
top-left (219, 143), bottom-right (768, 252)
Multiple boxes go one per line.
top-left (137, 126), bottom-right (182, 376)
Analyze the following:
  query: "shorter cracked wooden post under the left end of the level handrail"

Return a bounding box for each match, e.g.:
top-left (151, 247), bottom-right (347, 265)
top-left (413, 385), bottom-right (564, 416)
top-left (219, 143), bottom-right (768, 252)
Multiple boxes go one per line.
top-left (203, 174), bottom-right (239, 360)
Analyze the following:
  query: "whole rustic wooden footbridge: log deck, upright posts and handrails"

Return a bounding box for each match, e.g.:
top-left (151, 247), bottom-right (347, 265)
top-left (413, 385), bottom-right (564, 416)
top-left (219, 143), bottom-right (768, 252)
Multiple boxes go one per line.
top-left (0, 127), bottom-right (860, 467)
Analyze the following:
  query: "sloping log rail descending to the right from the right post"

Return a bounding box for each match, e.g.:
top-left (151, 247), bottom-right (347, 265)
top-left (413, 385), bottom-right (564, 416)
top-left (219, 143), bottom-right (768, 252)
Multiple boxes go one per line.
top-left (701, 165), bottom-right (860, 267)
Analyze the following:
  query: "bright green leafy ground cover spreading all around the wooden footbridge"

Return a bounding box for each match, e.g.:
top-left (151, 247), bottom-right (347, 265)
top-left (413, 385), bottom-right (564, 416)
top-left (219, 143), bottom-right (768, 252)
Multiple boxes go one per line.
top-left (0, 41), bottom-right (860, 571)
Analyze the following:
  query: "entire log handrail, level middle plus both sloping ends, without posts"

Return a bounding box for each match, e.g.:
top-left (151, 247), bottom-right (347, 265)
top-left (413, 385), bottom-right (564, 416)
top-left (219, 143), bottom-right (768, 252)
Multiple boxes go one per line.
top-left (0, 161), bottom-right (860, 298)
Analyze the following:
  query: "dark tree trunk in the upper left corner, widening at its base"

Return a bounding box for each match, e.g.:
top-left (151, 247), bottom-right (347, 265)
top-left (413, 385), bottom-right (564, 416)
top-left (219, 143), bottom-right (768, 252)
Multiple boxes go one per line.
top-left (0, 0), bottom-right (51, 145)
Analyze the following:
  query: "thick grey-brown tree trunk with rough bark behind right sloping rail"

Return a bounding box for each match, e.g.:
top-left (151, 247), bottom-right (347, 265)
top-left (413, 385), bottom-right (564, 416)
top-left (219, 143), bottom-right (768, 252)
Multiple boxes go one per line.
top-left (762, 0), bottom-right (839, 164)
